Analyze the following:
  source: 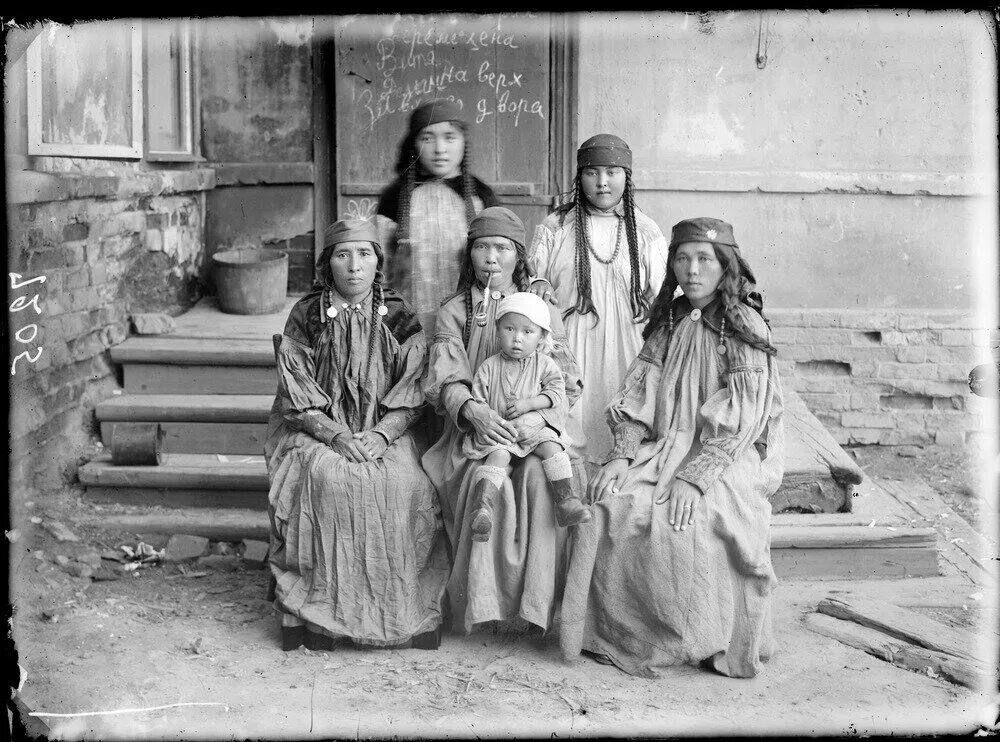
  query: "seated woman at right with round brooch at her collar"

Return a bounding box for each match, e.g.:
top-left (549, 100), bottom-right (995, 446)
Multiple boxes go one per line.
top-left (560, 218), bottom-right (784, 677)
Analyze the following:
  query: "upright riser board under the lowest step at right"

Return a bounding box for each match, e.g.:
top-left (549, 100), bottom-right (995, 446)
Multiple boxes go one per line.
top-left (771, 544), bottom-right (940, 580)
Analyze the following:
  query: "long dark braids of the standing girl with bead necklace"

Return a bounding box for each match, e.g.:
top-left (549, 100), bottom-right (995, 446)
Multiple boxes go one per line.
top-left (556, 174), bottom-right (649, 322)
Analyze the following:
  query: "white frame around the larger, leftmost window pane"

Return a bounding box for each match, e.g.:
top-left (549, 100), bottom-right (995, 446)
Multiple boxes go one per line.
top-left (27, 24), bottom-right (146, 160)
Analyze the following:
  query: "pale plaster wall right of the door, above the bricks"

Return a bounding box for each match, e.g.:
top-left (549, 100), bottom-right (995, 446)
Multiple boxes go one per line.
top-left (578, 11), bottom-right (996, 309)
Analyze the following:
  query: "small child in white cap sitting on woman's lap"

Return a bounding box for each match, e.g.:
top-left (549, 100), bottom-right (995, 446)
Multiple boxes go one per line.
top-left (462, 292), bottom-right (591, 541)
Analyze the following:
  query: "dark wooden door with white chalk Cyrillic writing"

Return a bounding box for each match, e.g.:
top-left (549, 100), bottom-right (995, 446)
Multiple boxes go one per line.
top-left (334, 13), bottom-right (573, 250)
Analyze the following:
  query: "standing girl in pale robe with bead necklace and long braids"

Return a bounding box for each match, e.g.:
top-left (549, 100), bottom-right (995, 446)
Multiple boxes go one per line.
top-left (529, 134), bottom-right (667, 464)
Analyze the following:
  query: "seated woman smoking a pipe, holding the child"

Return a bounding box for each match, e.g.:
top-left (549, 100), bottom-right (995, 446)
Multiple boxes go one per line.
top-left (423, 206), bottom-right (585, 633)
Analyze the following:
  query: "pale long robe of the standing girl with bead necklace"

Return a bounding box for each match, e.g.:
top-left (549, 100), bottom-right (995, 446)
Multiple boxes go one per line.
top-left (529, 204), bottom-right (667, 464)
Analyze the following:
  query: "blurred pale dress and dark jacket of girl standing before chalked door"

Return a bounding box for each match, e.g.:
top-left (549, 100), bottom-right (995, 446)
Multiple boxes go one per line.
top-left (378, 176), bottom-right (496, 337)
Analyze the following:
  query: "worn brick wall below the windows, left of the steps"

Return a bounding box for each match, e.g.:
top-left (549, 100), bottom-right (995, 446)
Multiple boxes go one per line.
top-left (7, 170), bottom-right (212, 491)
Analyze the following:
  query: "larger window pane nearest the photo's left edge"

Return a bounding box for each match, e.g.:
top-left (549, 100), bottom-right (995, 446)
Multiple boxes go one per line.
top-left (39, 22), bottom-right (132, 146)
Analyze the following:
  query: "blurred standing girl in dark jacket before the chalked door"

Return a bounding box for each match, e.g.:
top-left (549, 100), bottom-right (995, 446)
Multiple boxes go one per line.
top-left (378, 99), bottom-right (496, 338)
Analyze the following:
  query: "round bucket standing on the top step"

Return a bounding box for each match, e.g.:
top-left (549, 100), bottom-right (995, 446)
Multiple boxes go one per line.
top-left (212, 250), bottom-right (288, 314)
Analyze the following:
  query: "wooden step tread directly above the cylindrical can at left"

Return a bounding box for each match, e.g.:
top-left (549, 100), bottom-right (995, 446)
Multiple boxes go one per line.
top-left (96, 394), bottom-right (274, 423)
